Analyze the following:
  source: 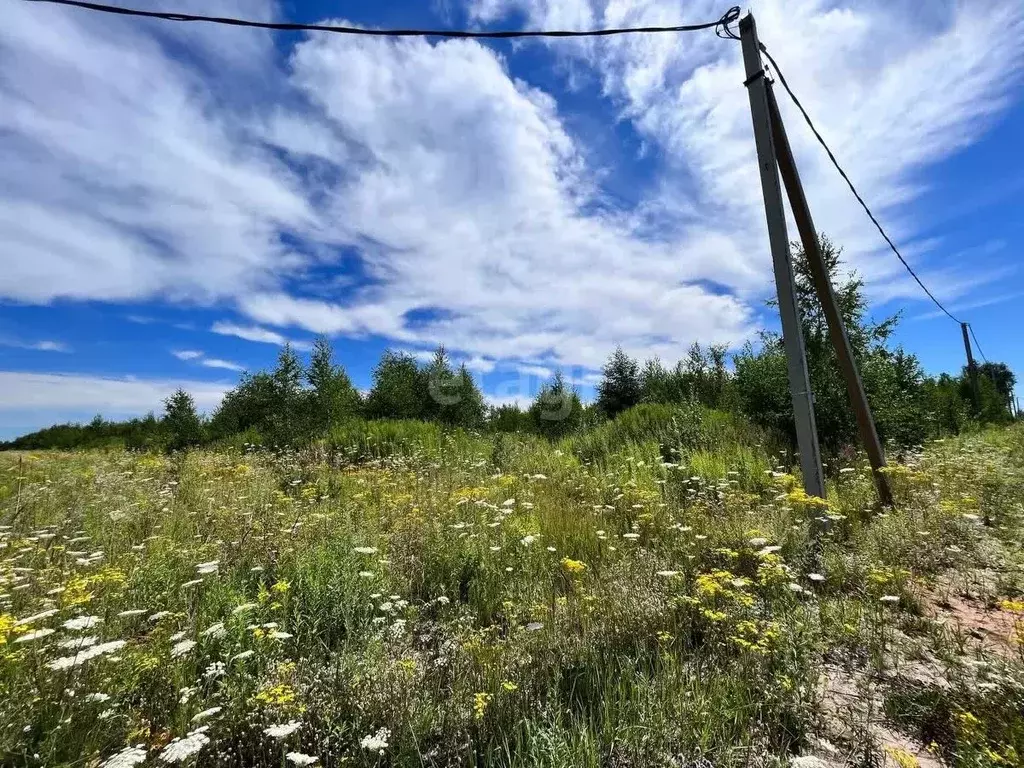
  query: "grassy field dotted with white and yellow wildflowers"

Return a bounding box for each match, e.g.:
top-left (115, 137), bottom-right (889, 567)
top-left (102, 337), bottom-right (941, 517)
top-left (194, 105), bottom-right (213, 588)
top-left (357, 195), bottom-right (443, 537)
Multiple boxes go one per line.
top-left (0, 423), bottom-right (1024, 768)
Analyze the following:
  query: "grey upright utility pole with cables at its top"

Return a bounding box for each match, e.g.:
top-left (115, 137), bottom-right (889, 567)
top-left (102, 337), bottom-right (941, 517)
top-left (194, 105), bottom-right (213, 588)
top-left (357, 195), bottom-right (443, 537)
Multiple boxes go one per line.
top-left (739, 13), bottom-right (825, 499)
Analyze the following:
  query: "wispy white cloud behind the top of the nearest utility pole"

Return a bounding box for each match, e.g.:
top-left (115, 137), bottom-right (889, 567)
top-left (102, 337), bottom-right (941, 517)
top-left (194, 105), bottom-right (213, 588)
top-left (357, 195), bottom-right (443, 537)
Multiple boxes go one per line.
top-left (472, 0), bottom-right (1024, 307)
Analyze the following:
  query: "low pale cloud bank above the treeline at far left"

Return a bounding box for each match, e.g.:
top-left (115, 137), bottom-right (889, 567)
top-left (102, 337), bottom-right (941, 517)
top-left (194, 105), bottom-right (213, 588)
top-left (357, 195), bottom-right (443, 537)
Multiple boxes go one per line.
top-left (0, 371), bottom-right (228, 436)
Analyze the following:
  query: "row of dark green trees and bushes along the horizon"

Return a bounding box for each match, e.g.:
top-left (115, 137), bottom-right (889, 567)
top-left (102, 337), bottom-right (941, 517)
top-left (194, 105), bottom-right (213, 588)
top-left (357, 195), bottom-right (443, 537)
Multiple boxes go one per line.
top-left (0, 237), bottom-right (1016, 454)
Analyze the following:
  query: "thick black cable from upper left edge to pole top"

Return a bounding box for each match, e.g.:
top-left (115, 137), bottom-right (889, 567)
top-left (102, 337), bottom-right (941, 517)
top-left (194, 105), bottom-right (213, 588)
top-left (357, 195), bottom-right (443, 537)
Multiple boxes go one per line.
top-left (19, 0), bottom-right (739, 40)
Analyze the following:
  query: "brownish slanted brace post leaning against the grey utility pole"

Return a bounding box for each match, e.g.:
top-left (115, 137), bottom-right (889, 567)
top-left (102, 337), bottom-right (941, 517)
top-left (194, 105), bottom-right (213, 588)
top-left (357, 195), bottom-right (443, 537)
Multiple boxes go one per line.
top-left (762, 83), bottom-right (893, 506)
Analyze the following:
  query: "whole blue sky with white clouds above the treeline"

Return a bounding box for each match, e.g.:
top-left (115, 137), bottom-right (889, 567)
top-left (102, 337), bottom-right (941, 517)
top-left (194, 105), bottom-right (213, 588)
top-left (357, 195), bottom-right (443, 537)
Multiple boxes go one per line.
top-left (0, 0), bottom-right (1024, 437)
